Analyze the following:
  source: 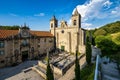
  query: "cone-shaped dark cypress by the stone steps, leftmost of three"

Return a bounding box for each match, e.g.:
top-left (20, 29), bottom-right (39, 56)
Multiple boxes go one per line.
top-left (46, 53), bottom-right (54, 80)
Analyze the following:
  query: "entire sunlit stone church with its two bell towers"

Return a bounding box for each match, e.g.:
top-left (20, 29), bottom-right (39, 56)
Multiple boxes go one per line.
top-left (50, 9), bottom-right (86, 53)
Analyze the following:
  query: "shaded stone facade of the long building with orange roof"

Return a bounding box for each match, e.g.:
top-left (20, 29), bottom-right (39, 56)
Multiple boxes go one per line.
top-left (0, 37), bottom-right (54, 67)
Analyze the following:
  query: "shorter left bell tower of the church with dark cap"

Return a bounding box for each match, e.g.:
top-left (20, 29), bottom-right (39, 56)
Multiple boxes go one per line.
top-left (50, 16), bottom-right (58, 35)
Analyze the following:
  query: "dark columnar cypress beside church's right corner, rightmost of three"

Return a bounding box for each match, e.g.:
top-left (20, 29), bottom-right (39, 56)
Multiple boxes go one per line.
top-left (86, 36), bottom-right (92, 64)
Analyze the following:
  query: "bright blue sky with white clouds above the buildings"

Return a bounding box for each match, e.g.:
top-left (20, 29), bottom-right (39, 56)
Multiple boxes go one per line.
top-left (0, 0), bottom-right (120, 31)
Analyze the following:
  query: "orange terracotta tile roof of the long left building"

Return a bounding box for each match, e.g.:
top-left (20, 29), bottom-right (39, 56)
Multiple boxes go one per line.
top-left (0, 30), bottom-right (53, 38)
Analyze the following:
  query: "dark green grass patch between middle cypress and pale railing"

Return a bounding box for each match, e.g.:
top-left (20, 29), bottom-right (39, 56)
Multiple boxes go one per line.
top-left (80, 64), bottom-right (95, 80)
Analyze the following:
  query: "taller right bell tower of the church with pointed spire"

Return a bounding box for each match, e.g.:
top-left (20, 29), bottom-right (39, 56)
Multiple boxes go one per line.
top-left (71, 8), bottom-right (81, 28)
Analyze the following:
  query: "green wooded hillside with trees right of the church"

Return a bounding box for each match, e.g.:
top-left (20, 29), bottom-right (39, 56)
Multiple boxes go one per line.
top-left (91, 21), bottom-right (120, 55)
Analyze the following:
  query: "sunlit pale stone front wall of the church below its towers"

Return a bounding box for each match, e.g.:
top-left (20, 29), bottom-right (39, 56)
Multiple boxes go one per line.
top-left (51, 27), bottom-right (85, 53)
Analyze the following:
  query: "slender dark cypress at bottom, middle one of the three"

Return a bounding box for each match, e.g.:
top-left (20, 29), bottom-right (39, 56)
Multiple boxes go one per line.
top-left (75, 49), bottom-right (81, 80)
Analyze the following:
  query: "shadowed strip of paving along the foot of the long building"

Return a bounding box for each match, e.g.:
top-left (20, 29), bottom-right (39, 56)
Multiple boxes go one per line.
top-left (0, 61), bottom-right (38, 80)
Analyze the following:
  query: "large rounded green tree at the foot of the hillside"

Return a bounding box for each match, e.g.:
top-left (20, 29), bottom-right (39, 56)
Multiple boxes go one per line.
top-left (95, 36), bottom-right (117, 55)
